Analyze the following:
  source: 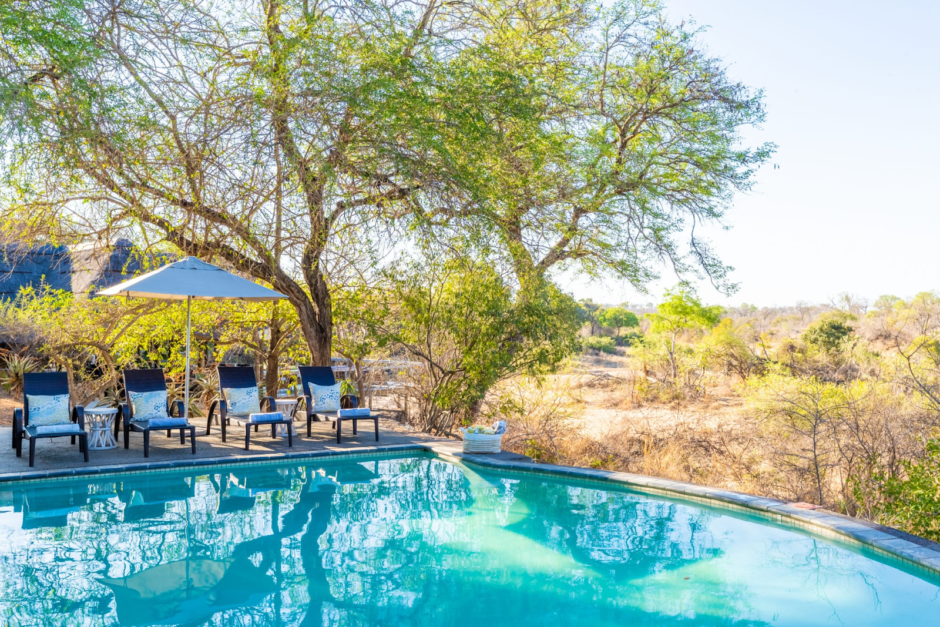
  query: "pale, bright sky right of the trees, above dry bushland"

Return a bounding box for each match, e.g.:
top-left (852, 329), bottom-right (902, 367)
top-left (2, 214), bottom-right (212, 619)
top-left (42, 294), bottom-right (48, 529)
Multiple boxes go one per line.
top-left (562, 0), bottom-right (940, 305)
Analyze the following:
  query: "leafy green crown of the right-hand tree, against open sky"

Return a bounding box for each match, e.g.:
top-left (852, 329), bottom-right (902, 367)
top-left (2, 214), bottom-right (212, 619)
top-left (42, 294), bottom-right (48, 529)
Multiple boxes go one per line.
top-left (396, 0), bottom-right (774, 291)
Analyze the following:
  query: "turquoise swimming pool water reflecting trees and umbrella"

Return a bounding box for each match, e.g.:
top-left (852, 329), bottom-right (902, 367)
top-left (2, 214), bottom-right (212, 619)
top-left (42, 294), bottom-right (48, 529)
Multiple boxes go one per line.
top-left (0, 457), bottom-right (940, 627)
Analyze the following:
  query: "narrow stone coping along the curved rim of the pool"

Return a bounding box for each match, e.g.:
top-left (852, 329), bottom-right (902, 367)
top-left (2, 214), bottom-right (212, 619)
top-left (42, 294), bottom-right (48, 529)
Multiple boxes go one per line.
top-left (0, 441), bottom-right (940, 575)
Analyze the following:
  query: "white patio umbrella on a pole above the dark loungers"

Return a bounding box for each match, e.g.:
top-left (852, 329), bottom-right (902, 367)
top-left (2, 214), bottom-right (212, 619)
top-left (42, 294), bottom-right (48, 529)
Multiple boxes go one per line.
top-left (98, 257), bottom-right (287, 418)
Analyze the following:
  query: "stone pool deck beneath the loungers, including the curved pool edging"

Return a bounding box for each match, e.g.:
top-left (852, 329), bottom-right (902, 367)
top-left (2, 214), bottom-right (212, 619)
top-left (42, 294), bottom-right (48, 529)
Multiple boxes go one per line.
top-left (0, 419), bottom-right (940, 576)
